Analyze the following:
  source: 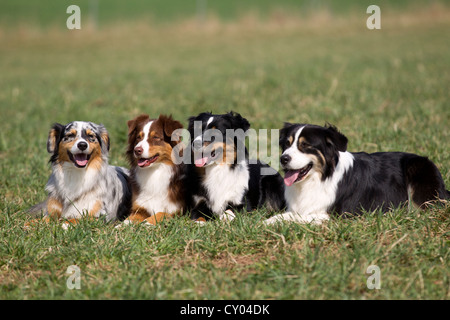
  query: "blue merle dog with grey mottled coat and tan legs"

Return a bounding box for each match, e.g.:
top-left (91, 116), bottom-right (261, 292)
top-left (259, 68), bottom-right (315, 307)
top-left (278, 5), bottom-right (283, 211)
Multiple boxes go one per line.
top-left (30, 121), bottom-right (131, 226)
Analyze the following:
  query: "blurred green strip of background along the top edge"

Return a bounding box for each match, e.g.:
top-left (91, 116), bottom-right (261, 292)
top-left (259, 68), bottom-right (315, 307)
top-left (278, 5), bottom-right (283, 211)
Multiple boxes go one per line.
top-left (0, 0), bottom-right (442, 26)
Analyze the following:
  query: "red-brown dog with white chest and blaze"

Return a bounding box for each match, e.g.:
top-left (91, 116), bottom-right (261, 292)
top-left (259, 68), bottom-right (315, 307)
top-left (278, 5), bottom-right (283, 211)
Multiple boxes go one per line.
top-left (124, 114), bottom-right (190, 225)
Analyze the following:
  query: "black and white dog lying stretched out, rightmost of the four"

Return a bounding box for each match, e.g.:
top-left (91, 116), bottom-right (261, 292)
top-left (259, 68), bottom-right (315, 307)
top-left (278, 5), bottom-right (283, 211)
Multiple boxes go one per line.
top-left (265, 123), bottom-right (450, 224)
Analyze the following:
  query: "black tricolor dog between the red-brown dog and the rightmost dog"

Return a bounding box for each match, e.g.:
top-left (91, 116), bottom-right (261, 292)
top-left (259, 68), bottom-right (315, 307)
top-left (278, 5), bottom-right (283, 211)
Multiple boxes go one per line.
top-left (188, 112), bottom-right (285, 219)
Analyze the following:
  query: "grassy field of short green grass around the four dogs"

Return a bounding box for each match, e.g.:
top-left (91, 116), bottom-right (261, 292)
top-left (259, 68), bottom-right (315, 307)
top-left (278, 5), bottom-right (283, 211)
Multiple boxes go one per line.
top-left (0, 1), bottom-right (450, 299)
